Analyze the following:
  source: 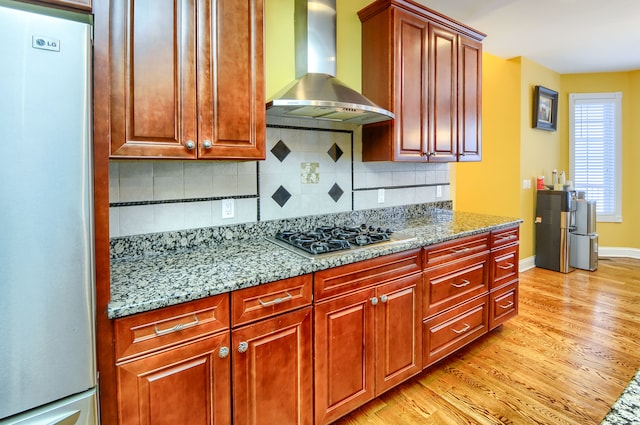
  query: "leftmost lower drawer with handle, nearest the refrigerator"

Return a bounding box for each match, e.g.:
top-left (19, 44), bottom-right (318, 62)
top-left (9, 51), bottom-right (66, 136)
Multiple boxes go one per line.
top-left (114, 294), bottom-right (229, 361)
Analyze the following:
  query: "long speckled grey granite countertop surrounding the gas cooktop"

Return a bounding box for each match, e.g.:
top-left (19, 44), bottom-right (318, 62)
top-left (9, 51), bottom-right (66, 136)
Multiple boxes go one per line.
top-left (108, 210), bottom-right (522, 318)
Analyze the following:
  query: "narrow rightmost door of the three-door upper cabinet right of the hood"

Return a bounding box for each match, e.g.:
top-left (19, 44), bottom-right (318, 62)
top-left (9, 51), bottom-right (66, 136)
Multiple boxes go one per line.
top-left (458, 36), bottom-right (482, 161)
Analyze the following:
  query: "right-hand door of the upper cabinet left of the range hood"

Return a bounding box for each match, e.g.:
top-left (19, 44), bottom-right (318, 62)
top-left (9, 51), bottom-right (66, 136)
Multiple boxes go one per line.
top-left (198, 0), bottom-right (266, 159)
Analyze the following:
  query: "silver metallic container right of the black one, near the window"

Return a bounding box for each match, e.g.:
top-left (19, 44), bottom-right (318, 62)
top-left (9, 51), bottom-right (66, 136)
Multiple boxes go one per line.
top-left (570, 197), bottom-right (598, 271)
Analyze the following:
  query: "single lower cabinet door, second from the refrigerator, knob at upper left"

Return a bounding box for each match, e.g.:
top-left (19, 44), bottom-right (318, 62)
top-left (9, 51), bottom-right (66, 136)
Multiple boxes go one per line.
top-left (232, 307), bottom-right (313, 425)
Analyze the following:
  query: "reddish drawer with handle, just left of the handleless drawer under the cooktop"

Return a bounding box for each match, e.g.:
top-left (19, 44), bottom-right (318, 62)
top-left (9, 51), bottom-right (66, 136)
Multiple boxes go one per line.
top-left (231, 274), bottom-right (313, 326)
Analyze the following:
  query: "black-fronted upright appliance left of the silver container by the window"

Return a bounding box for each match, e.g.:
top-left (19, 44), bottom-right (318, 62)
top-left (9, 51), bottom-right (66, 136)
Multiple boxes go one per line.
top-left (535, 190), bottom-right (576, 273)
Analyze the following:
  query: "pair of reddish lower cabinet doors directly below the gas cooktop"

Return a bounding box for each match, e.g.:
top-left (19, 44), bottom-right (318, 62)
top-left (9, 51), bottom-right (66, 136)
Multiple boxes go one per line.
top-left (314, 273), bottom-right (422, 424)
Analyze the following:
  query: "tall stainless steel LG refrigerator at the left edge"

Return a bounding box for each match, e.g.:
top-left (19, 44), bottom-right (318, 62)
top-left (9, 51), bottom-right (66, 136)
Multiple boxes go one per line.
top-left (0, 0), bottom-right (97, 425)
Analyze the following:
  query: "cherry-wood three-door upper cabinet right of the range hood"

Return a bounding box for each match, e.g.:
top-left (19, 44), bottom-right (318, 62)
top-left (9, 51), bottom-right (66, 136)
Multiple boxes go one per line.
top-left (358, 0), bottom-right (484, 162)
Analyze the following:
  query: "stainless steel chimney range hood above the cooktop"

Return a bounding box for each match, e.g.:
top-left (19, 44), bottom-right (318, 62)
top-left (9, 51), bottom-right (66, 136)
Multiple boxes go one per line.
top-left (267, 0), bottom-right (395, 125)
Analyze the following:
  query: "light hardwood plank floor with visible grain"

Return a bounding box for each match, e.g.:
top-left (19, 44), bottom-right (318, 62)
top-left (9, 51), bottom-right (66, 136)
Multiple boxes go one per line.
top-left (335, 258), bottom-right (640, 425)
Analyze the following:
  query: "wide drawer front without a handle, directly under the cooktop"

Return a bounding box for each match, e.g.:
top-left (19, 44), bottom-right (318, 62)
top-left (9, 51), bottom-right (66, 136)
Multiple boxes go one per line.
top-left (313, 248), bottom-right (422, 302)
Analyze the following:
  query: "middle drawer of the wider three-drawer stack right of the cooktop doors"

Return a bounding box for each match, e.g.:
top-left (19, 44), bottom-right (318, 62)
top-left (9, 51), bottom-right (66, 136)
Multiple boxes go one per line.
top-left (422, 253), bottom-right (489, 318)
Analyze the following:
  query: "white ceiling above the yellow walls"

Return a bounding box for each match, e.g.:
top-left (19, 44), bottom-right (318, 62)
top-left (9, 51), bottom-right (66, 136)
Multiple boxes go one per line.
top-left (415, 0), bottom-right (640, 74)
